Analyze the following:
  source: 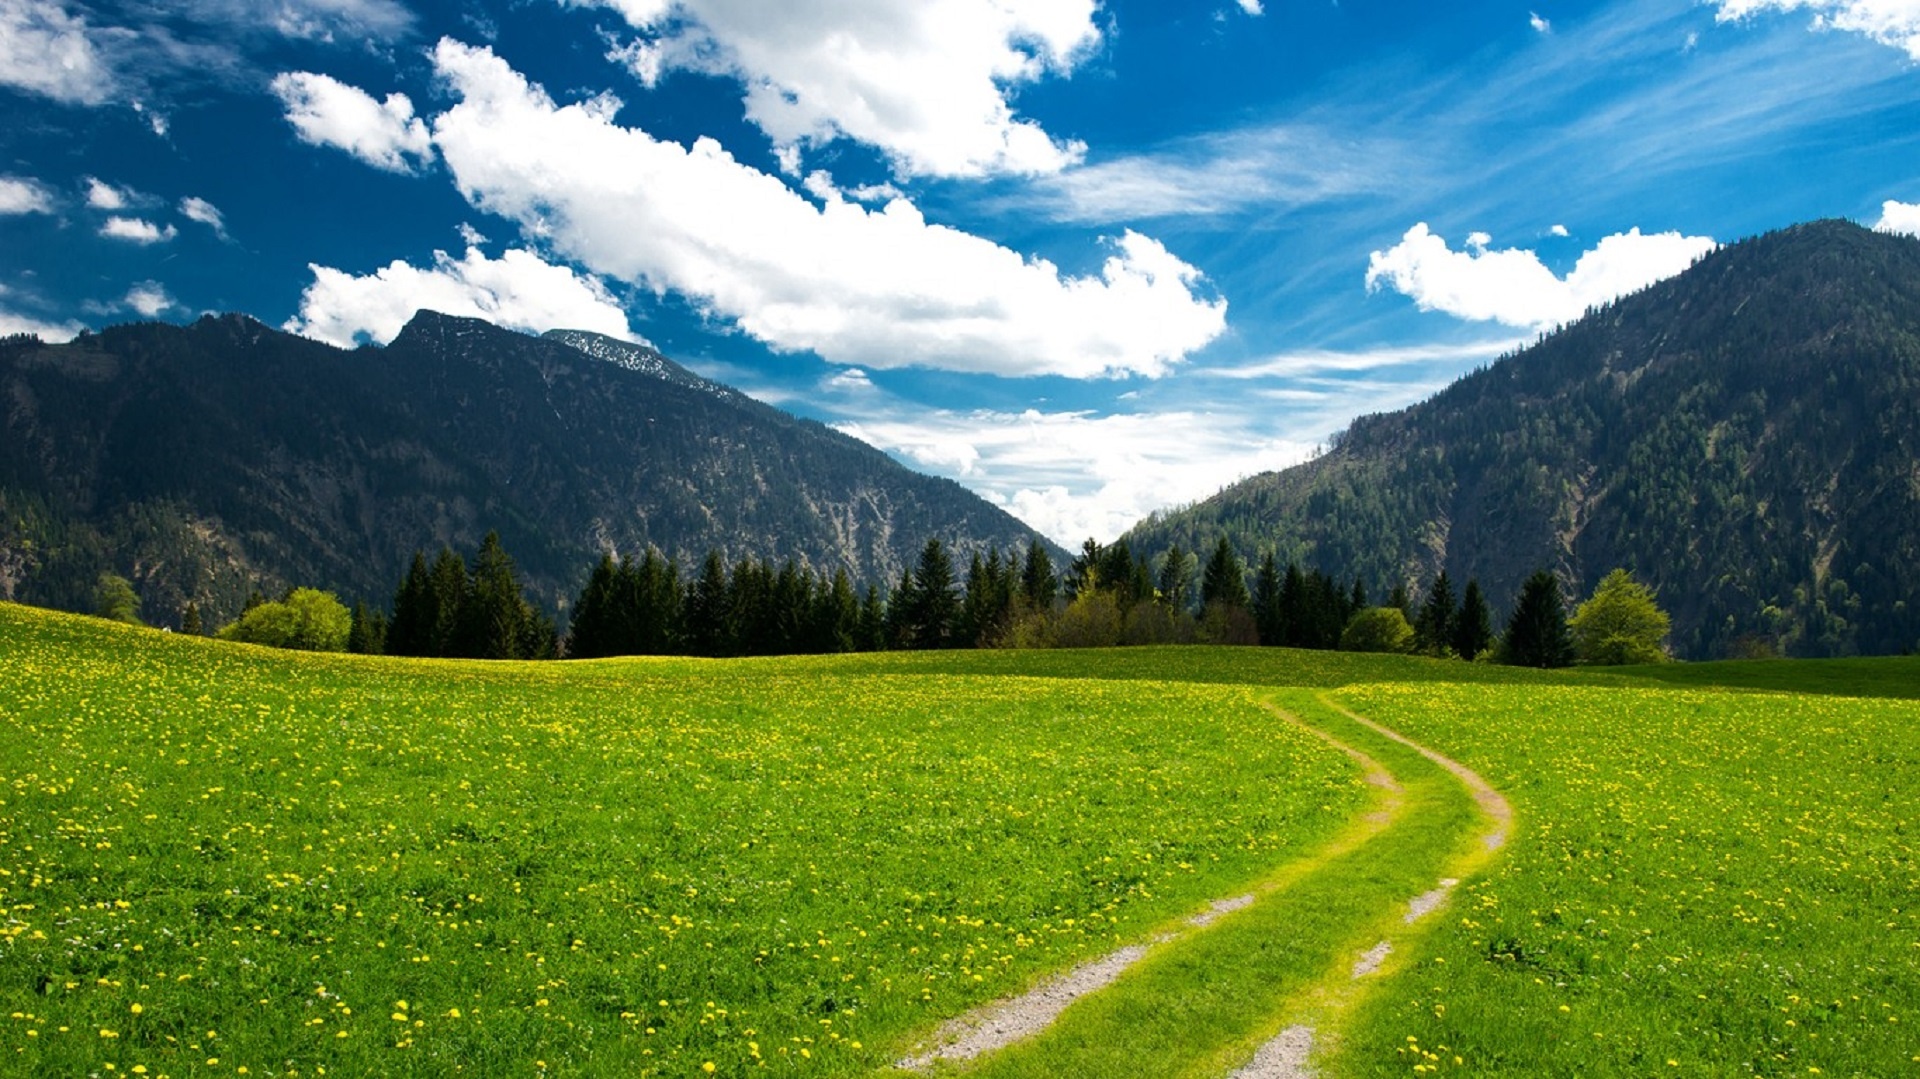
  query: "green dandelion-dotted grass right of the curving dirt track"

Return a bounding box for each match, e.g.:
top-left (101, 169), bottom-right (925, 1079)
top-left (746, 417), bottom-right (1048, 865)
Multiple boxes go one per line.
top-left (1342, 685), bottom-right (1920, 1075)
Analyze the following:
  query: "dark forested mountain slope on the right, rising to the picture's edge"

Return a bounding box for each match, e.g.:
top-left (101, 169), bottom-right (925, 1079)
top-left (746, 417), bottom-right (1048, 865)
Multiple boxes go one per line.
top-left (1127, 221), bottom-right (1920, 657)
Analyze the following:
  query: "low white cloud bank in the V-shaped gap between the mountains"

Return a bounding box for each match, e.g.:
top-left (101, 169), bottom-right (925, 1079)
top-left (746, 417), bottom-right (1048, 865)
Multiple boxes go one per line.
top-left (835, 409), bottom-right (1313, 547)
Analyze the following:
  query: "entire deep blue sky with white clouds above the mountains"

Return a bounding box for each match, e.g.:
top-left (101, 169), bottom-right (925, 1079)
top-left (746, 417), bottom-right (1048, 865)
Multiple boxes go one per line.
top-left (0, 0), bottom-right (1920, 545)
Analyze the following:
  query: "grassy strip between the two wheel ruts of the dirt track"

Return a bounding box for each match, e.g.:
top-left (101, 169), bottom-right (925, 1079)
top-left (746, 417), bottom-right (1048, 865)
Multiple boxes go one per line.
top-left (921, 691), bottom-right (1488, 1079)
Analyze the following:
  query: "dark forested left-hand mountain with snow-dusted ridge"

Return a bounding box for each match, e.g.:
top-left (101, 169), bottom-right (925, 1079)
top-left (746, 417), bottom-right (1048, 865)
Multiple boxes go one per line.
top-left (0, 311), bottom-right (1058, 622)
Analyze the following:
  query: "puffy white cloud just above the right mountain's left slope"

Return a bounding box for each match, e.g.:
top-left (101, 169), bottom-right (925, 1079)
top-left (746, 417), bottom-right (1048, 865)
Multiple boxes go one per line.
top-left (1367, 221), bottom-right (1715, 330)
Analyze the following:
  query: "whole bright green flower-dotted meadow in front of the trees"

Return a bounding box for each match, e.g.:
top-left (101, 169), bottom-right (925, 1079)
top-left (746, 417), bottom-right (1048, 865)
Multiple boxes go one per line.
top-left (0, 605), bottom-right (1920, 1077)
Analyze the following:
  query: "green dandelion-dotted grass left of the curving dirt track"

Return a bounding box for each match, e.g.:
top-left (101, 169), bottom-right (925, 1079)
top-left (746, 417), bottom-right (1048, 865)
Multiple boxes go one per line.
top-left (0, 607), bottom-right (1363, 1075)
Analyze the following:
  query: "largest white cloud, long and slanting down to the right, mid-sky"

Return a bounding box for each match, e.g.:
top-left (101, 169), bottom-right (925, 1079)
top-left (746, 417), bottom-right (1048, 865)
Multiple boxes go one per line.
top-left (434, 40), bottom-right (1227, 378)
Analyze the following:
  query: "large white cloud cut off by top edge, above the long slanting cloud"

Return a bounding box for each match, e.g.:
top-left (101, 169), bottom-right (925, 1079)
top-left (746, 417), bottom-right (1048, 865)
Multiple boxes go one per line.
top-left (579, 0), bottom-right (1098, 177)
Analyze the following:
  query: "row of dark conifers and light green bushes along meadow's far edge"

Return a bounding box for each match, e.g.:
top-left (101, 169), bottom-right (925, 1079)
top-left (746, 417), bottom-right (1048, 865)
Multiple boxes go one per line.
top-left (187, 532), bottom-right (1668, 666)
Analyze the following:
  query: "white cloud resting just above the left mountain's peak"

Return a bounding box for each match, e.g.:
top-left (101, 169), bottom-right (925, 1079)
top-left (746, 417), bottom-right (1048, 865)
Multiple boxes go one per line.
top-left (286, 248), bottom-right (636, 348)
